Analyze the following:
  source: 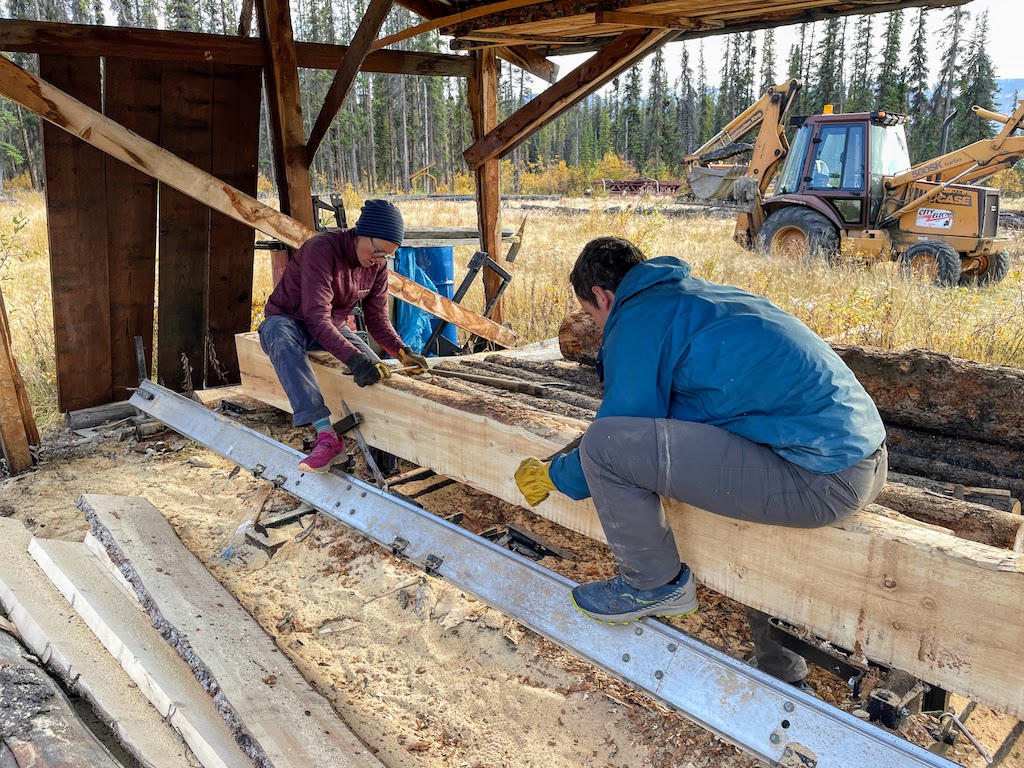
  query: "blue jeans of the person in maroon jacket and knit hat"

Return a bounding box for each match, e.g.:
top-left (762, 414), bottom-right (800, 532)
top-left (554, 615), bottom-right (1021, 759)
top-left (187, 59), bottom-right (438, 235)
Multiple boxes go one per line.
top-left (259, 314), bottom-right (380, 427)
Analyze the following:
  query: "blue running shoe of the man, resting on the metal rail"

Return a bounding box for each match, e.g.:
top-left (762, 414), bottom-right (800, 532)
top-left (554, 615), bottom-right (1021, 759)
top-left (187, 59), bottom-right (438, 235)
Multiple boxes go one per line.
top-left (572, 564), bottom-right (697, 624)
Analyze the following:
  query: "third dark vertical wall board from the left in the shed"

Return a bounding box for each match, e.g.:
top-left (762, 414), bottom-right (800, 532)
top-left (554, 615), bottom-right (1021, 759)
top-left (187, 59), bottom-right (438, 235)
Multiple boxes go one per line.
top-left (157, 62), bottom-right (213, 392)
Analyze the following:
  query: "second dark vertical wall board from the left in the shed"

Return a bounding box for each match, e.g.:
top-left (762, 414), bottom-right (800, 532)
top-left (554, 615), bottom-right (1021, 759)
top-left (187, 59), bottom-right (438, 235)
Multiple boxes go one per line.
top-left (103, 56), bottom-right (161, 400)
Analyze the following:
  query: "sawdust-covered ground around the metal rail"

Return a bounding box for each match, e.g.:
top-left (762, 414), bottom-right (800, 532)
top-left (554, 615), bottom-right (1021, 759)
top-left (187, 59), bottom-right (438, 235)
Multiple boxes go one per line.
top-left (0, 411), bottom-right (1024, 768)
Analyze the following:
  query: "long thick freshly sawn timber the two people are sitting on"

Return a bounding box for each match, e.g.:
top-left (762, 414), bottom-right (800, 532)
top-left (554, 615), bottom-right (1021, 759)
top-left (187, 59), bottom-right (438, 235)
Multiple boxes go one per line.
top-left (238, 334), bottom-right (1024, 717)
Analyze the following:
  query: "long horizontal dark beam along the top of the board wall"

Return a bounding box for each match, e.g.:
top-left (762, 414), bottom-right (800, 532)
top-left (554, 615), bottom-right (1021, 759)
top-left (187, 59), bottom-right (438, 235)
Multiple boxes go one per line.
top-left (0, 18), bottom-right (473, 78)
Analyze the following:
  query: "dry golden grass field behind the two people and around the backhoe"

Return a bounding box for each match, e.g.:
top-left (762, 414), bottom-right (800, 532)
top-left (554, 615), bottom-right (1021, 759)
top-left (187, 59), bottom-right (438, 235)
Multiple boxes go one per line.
top-left (0, 196), bottom-right (1024, 436)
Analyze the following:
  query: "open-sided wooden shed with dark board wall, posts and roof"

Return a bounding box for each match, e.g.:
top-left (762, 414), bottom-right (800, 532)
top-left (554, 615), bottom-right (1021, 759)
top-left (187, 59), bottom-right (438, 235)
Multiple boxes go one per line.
top-left (0, 0), bottom-right (958, 428)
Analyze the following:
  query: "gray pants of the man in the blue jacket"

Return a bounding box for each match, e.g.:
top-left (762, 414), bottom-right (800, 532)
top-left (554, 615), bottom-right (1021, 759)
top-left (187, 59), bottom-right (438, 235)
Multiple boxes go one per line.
top-left (580, 417), bottom-right (888, 682)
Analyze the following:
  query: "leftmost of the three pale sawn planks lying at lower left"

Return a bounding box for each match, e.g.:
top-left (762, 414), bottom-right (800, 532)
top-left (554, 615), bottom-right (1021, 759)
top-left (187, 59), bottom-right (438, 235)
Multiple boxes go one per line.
top-left (0, 519), bottom-right (195, 768)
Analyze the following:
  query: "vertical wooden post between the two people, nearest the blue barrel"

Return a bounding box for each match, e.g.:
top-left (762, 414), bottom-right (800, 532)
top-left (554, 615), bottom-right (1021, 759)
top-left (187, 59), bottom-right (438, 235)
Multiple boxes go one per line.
top-left (467, 50), bottom-right (505, 323)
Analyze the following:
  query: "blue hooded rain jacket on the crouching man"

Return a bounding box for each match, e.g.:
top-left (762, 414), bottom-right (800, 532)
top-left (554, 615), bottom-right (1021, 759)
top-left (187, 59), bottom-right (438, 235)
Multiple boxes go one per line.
top-left (550, 256), bottom-right (886, 499)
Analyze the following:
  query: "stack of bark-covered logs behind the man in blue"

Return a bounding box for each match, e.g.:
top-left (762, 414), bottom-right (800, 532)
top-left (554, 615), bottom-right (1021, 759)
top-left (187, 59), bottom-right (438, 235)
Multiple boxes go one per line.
top-left (558, 312), bottom-right (1024, 552)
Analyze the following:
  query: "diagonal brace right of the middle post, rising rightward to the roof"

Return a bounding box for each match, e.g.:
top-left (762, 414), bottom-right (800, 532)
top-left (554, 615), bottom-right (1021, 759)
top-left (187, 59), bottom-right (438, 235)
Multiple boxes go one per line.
top-left (463, 30), bottom-right (670, 170)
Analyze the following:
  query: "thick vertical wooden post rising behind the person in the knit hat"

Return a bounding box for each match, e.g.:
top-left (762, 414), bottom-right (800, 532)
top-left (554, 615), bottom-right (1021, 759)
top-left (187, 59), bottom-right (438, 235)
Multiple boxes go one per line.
top-left (259, 0), bottom-right (313, 226)
